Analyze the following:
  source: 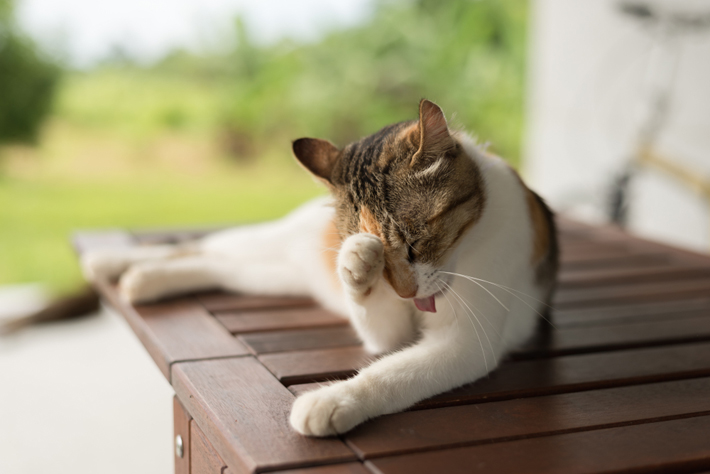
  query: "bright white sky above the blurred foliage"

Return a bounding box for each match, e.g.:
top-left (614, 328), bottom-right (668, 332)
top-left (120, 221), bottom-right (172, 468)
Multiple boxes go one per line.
top-left (17, 0), bottom-right (372, 67)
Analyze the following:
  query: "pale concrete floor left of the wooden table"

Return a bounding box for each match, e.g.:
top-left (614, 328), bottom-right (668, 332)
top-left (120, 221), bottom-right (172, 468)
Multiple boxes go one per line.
top-left (0, 286), bottom-right (173, 474)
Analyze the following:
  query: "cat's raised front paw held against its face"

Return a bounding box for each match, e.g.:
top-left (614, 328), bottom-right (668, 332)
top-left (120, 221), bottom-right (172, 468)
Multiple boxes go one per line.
top-left (338, 234), bottom-right (385, 294)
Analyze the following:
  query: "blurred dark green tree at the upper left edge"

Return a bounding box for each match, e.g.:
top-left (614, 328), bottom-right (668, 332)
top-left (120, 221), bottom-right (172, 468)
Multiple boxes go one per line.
top-left (0, 0), bottom-right (60, 143)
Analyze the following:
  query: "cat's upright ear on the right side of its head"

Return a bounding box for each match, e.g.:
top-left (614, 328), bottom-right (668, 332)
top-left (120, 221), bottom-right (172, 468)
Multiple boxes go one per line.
top-left (411, 99), bottom-right (455, 167)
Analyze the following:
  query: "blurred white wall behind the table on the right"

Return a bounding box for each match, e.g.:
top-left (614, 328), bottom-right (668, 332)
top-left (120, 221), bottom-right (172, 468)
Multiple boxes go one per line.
top-left (525, 0), bottom-right (710, 251)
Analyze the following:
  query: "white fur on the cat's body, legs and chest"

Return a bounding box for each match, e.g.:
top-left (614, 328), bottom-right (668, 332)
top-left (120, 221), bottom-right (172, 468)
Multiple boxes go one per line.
top-left (83, 134), bottom-right (543, 436)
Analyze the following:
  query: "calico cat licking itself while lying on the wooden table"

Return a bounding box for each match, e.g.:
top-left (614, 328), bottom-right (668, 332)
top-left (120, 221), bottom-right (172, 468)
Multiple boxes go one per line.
top-left (82, 100), bottom-right (558, 436)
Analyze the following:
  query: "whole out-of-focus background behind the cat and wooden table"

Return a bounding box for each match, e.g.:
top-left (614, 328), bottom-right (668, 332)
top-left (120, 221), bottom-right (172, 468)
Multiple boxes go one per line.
top-left (0, 0), bottom-right (710, 473)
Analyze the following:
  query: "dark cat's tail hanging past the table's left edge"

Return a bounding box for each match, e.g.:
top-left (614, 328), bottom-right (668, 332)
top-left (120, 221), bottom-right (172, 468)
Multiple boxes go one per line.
top-left (0, 285), bottom-right (99, 335)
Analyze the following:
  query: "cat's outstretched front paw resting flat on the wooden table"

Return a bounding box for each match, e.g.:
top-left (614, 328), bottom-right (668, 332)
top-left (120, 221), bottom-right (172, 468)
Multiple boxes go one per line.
top-left (290, 382), bottom-right (368, 436)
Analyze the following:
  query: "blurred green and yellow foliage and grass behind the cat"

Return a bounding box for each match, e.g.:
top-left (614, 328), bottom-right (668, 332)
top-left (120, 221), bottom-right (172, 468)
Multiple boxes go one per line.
top-left (0, 0), bottom-right (527, 290)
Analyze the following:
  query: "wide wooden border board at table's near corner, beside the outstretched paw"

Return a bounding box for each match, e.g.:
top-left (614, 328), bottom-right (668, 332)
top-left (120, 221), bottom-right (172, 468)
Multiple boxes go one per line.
top-left (173, 357), bottom-right (355, 474)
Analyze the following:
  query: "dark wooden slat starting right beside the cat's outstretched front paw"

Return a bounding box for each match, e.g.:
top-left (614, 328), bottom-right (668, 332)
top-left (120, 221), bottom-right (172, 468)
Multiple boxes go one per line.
top-left (345, 378), bottom-right (710, 459)
